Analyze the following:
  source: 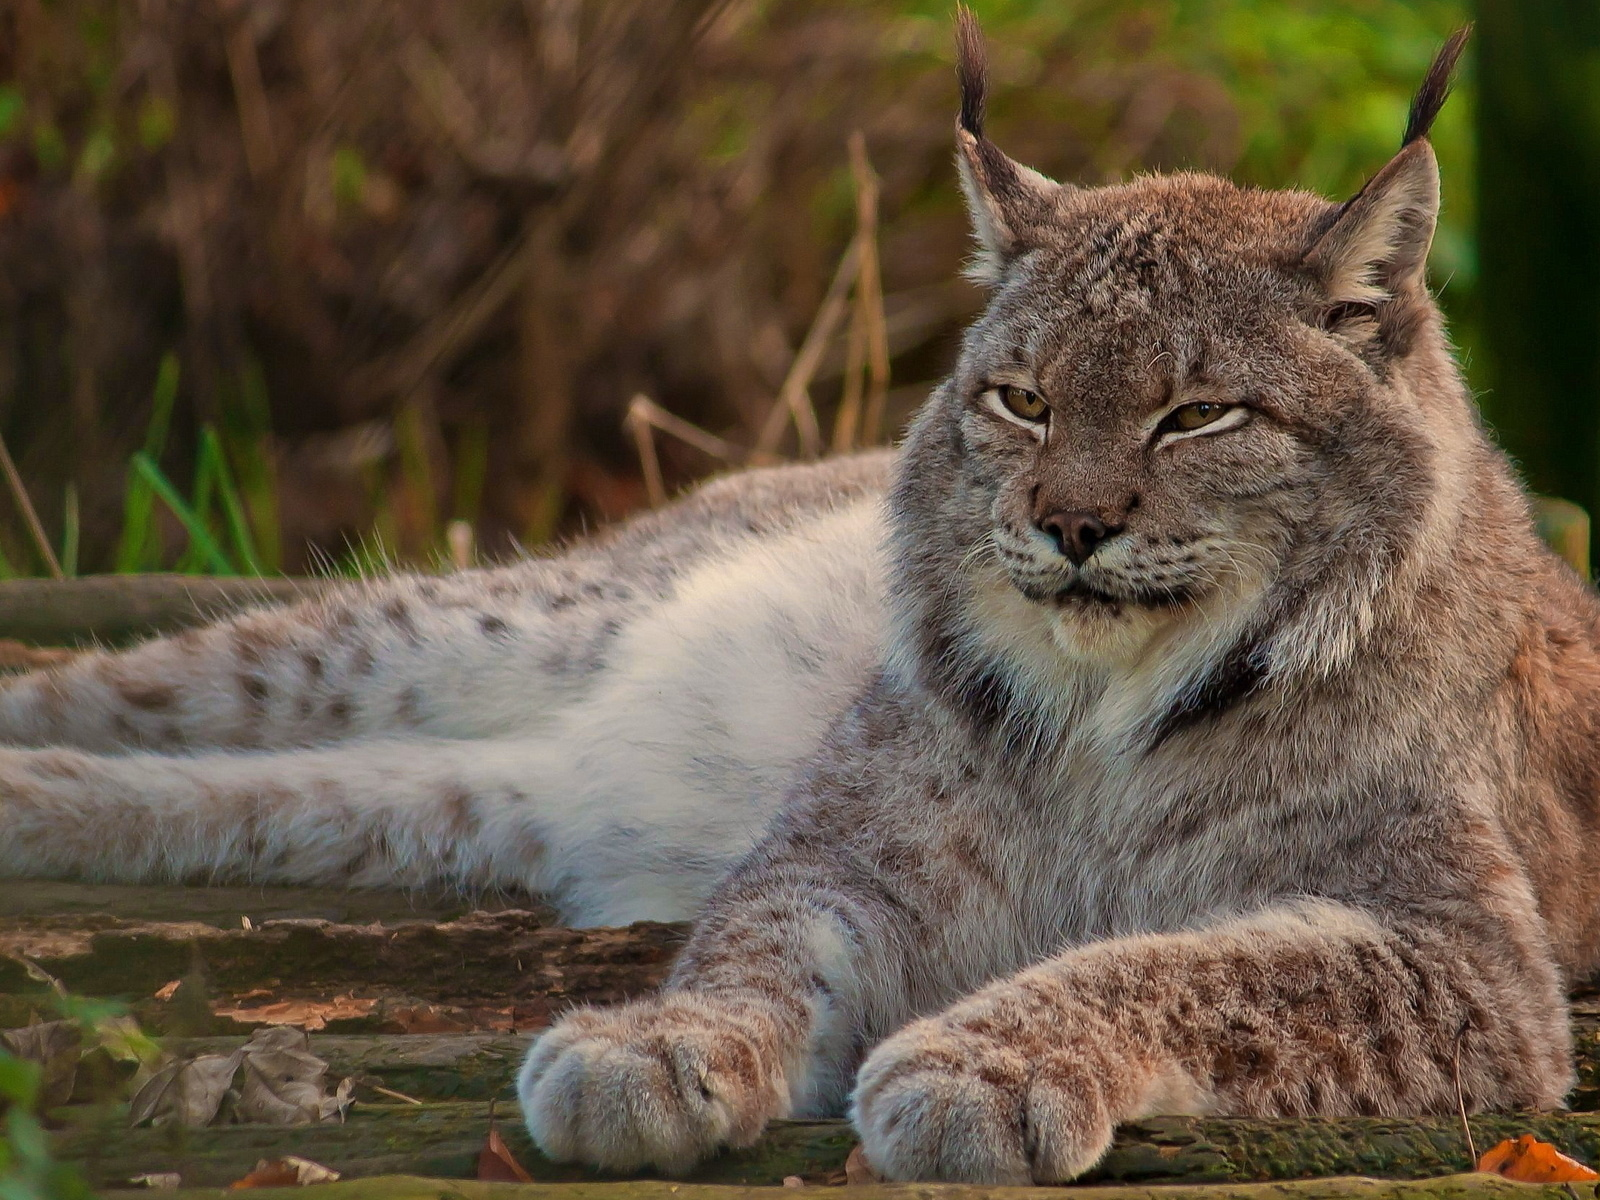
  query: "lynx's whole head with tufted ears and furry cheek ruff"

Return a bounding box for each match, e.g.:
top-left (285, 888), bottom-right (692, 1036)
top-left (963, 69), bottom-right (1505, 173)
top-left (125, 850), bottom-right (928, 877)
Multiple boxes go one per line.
top-left (894, 18), bottom-right (1488, 748)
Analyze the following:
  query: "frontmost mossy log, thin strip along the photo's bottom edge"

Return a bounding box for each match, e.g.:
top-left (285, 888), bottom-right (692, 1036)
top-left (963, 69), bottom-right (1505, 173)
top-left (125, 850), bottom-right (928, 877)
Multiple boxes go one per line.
top-left (84, 1174), bottom-right (1589, 1200)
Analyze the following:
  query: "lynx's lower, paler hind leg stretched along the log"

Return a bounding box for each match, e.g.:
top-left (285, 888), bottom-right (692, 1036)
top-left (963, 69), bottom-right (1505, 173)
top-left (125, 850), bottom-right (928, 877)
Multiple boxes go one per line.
top-left (0, 741), bottom-right (558, 890)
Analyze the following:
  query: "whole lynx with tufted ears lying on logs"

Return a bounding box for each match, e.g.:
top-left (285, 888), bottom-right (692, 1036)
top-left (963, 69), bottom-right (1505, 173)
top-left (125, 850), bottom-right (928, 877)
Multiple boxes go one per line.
top-left (0, 14), bottom-right (1600, 1184)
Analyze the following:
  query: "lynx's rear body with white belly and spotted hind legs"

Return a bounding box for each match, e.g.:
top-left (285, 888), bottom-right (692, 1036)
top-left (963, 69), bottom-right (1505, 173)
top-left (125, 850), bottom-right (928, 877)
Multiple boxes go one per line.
top-left (0, 453), bottom-right (891, 925)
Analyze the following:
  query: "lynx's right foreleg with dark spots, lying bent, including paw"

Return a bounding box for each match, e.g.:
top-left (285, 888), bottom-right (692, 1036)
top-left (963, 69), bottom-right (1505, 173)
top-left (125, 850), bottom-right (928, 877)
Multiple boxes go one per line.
top-left (853, 902), bottom-right (1571, 1184)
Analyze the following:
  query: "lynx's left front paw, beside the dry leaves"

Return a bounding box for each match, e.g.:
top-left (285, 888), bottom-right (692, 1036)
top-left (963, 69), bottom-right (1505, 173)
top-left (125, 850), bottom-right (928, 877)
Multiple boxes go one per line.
top-left (517, 994), bottom-right (789, 1174)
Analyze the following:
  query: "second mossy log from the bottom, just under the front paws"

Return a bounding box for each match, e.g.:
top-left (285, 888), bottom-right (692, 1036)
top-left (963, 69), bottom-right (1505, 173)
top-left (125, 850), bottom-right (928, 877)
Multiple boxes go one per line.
top-left (54, 1102), bottom-right (1600, 1200)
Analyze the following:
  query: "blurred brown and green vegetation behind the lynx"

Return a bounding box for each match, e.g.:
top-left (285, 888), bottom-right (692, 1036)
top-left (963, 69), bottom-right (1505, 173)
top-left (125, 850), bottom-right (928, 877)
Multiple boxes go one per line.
top-left (0, 0), bottom-right (1477, 573)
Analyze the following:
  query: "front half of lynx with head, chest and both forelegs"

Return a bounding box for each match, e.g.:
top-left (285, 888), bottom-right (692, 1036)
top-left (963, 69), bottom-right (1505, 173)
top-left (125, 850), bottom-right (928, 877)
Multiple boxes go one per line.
top-left (520, 14), bottom-right (1600, 1184)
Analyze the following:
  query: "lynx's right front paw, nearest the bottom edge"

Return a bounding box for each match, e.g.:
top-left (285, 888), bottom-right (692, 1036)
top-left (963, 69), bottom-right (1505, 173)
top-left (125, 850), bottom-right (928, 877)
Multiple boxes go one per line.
top-left (851, 1019), bottom-right (1114, 1184)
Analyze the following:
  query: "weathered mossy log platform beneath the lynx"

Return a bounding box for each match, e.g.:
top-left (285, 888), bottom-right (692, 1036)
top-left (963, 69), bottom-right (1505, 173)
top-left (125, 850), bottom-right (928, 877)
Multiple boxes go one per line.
top-left (9, 883), bottom-right (1600, 1200)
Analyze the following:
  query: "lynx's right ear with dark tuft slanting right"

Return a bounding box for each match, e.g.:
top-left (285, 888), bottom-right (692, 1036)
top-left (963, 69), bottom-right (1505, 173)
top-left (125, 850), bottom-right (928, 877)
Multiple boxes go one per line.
top-left (1306, 26), bottom-right (1472, 309)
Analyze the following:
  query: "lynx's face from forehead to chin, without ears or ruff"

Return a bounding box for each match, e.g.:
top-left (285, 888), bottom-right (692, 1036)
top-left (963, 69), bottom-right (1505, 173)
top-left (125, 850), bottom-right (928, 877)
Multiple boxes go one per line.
top-left (950, 181), bottom-right (1324, 624)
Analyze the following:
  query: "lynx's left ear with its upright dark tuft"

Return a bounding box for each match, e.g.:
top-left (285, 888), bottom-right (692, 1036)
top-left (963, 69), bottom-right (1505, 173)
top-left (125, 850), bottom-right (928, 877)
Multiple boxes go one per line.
top-left (955, 5), bottom-right (1070, 285)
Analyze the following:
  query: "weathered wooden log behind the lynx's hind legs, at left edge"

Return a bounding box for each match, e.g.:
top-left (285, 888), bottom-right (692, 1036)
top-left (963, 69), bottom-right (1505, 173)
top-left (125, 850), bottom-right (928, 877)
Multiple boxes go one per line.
top-left (0, 574), bottom-right (332, 646)
